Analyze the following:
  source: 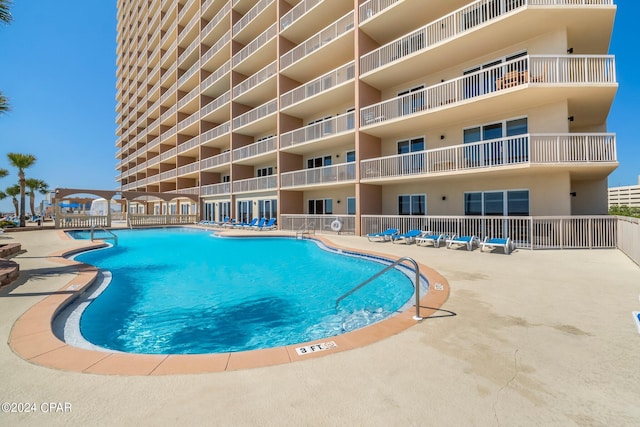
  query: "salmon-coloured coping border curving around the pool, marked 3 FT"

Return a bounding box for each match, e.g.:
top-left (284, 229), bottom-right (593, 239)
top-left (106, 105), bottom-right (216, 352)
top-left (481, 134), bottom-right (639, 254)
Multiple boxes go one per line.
top-left (8, 230), bottom-right (450, 376)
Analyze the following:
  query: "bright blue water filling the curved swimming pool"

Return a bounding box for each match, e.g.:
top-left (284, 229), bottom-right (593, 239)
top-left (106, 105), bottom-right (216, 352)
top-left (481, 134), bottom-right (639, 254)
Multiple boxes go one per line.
top-left (67, 228), bottom-right (414, 354)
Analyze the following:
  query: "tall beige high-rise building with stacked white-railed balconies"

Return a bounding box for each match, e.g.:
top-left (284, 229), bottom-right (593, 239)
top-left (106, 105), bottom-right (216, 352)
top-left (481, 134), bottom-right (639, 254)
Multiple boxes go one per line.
top-left (117, 0), bottom-right (618, 234)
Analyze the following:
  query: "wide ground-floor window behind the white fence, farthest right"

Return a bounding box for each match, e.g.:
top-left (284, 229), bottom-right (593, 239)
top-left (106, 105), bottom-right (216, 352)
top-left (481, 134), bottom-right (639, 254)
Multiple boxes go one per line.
top-left (464, 190), bottom-right (529, 216)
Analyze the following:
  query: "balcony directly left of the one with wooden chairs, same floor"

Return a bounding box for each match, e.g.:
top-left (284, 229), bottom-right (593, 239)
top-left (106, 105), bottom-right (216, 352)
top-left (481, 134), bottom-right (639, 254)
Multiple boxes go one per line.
top-left (280, 112), bottom-right (355, 154)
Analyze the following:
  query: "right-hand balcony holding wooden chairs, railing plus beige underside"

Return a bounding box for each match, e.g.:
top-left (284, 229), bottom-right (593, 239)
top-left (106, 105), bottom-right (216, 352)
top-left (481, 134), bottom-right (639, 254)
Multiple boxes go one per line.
top-left (360, 55), bottom-right (617, 136)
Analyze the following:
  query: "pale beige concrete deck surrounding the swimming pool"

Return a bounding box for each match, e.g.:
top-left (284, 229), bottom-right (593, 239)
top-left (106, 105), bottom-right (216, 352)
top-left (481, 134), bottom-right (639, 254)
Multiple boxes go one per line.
top-left (0, 230), bottom-right (640, 426)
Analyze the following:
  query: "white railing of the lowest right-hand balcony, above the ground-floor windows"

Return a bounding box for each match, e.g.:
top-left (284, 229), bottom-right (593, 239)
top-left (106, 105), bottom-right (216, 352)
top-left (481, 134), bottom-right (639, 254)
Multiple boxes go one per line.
top-left (360, 133), bottom-right (617, 180)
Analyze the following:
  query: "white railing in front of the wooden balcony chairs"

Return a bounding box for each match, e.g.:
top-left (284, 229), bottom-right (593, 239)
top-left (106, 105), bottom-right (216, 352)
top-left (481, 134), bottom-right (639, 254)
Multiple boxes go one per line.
top-left (360, 55), bottom-right (616, 126)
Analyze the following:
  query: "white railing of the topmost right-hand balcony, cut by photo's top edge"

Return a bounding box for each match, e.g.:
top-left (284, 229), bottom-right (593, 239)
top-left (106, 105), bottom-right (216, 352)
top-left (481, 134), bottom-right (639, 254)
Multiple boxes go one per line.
top-left (360, 0), bottom-right (613, 74)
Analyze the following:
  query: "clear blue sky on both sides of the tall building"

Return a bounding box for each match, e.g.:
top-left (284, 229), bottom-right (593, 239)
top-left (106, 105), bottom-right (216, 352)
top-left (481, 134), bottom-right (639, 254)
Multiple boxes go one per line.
top-left (0, 0), bottom-right (640, 212)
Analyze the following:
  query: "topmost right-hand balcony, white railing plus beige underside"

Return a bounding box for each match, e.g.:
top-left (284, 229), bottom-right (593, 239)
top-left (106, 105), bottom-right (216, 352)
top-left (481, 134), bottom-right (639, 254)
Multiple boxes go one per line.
top-left (360, 0), bottom-right (615, 88)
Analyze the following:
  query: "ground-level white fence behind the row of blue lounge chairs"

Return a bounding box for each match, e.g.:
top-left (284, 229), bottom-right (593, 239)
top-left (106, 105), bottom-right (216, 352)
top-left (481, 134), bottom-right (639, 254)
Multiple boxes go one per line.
top-left (361, 215), bottom-right (617, 249)
